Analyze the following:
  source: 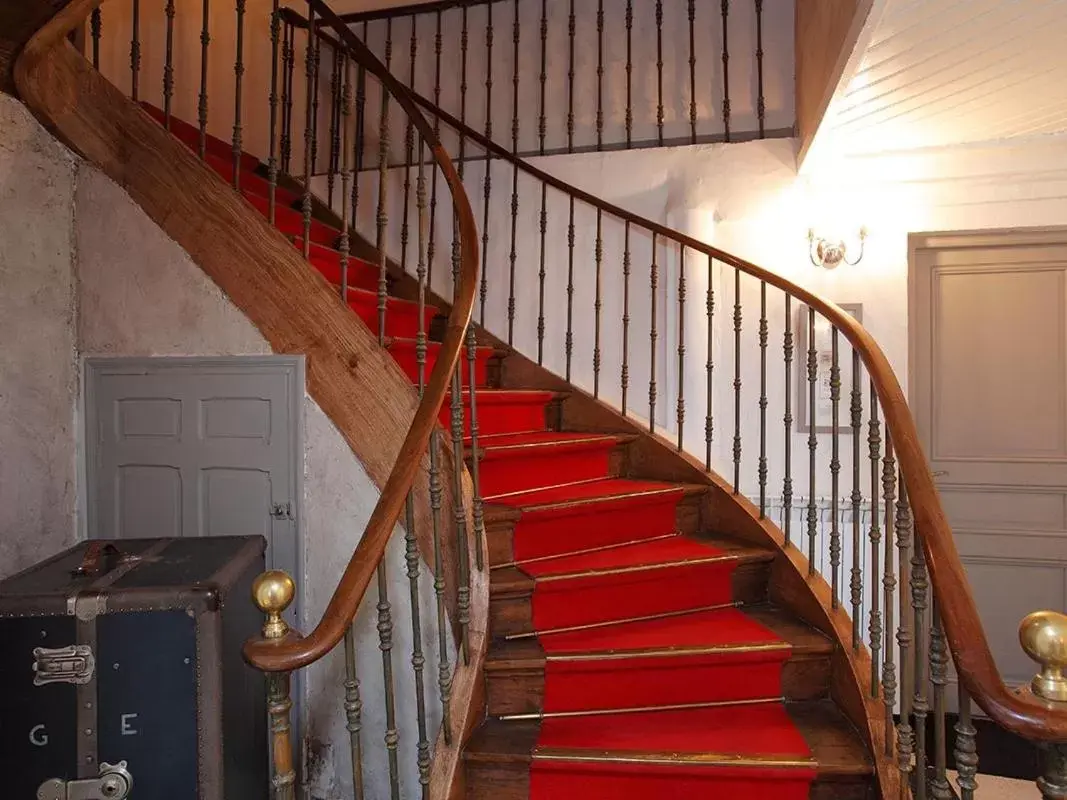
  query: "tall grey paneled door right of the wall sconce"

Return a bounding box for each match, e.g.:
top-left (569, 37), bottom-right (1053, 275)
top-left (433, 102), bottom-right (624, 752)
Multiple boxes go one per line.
top-left (909, 230), bottom-right (1067, 699)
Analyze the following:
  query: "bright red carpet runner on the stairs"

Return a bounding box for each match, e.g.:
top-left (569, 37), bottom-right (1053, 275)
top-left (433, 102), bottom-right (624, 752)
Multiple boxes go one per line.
top-left (148, 109), bottom-right (815, 800)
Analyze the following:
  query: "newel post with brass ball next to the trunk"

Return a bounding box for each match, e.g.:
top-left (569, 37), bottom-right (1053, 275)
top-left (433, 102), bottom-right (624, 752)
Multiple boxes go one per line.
top-left (252, 570), bottom-right (297, 800)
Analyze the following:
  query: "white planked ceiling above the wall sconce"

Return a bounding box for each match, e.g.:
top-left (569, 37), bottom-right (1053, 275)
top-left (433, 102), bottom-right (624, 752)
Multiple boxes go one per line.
top-left (825, 0), bottom-right (1067, 153)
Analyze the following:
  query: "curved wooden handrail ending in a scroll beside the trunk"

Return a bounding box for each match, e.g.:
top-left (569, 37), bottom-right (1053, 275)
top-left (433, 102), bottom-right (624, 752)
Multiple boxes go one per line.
top-left (244, 0), bottom-right (478, 672)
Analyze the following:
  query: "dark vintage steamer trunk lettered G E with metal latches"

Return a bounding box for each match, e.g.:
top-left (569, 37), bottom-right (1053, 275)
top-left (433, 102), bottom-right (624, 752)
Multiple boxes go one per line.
top-left (0, 537), bottom-right (268, 800)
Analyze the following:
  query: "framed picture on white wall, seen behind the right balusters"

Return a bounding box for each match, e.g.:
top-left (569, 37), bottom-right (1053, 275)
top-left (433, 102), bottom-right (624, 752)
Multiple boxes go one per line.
top-left (793, 303), bottom-right (867, 434)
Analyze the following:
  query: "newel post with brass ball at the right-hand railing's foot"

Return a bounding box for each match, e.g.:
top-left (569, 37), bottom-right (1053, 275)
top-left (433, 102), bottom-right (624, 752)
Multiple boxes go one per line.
top-left (1019, 611), bottom-right (1067, 800)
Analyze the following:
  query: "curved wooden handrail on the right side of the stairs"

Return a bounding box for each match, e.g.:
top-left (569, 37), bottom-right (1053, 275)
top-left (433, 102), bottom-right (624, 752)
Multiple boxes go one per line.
top-left (392, 84), bottom-right (1067, 741)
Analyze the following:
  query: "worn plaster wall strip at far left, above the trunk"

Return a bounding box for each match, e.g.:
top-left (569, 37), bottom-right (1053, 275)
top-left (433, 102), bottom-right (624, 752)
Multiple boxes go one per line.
top-left (0, 93), bottom-right (78, 577)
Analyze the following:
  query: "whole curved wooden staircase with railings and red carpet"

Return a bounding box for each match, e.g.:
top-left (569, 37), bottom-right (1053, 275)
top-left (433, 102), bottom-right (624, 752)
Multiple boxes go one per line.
top-left (19, 0), bottom-right (1067, 800)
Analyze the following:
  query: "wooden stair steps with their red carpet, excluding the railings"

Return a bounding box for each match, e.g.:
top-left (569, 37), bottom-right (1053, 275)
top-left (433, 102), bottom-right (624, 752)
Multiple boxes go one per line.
top-left (145, 107), bottom-right (878, 800)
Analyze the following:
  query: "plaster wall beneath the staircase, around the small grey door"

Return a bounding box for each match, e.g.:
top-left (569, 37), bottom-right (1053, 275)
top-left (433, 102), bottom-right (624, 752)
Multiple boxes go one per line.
top-left (75, 164), bottom-right (455, 800)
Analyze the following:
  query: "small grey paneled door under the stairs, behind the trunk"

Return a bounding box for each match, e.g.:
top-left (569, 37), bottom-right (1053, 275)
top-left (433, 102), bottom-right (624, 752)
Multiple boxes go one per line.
top-left (85, 356), bottom-right (304, 575)
